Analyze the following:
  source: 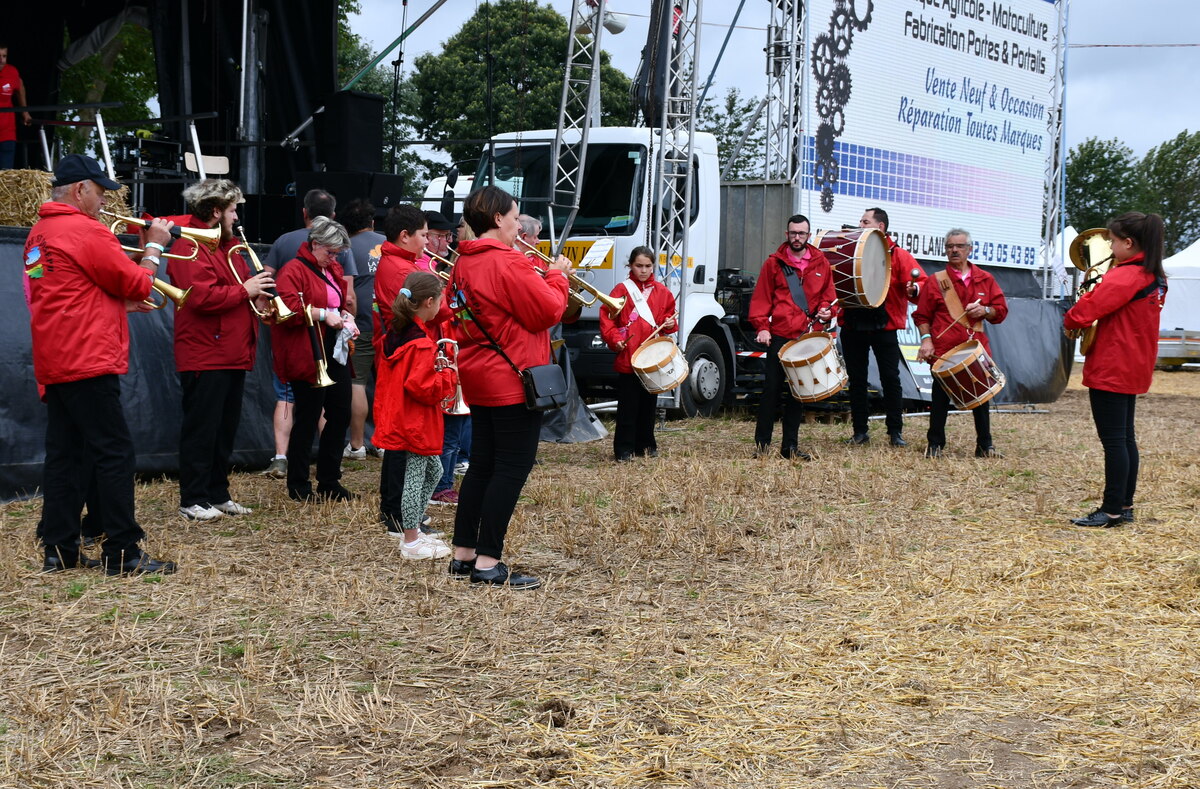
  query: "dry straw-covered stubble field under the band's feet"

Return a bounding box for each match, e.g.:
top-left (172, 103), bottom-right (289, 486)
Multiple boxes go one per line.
top-left (0, 372), bottom-right (1200, 789)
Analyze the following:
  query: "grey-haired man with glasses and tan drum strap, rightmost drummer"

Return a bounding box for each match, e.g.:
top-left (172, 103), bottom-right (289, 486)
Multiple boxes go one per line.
top-left (912, 228), bottom-right (1008, 458)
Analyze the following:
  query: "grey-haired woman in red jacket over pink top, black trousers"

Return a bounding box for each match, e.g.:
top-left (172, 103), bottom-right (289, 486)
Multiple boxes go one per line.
top-left (271, 217), bottom-right (358, 501)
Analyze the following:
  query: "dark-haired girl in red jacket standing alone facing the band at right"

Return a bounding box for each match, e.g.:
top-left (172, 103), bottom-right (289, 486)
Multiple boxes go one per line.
top-left (1063, 211), bottom-right (1166, 528)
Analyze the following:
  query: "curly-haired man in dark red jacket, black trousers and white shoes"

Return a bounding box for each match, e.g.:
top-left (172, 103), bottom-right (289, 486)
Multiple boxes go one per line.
top-left (170, 179), bottom-right (275, 520)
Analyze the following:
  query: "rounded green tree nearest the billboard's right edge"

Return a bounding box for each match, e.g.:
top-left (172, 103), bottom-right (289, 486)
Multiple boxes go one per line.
top-left (1063, 137), bottom-right (1141, 233)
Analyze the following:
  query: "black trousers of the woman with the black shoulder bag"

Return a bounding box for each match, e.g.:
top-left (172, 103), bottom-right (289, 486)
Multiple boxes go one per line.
top-left (454, 403), bottom-right (541, 559)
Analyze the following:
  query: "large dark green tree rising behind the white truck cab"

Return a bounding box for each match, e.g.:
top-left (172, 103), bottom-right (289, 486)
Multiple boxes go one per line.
top-left (413, 0), bottom-right (630, 161)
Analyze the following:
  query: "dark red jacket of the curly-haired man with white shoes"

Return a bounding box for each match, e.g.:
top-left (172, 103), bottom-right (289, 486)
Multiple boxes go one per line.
top-left (167, 216), bottom-right (258, 373)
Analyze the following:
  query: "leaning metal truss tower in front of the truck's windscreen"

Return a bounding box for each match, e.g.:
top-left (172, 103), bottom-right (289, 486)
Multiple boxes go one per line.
top-left (548, 0), bottom-right (605, 255)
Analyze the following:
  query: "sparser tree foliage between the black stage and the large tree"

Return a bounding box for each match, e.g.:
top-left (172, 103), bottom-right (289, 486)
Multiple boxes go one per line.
top-left (337, 0), bottom-right (442, 190)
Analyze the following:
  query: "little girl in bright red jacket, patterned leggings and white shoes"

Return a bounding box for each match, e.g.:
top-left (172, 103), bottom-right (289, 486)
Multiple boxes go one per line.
top-left (373, 271), bottom-right (456, 559)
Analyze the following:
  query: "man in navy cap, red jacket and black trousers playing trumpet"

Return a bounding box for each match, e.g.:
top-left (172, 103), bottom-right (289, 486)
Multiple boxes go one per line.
top-left (25, 153), bottom-right (175, 576)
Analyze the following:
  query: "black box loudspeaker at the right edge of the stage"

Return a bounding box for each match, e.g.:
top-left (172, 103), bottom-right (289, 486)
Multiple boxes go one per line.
top-left (316, 90), bottom-right (384, 172)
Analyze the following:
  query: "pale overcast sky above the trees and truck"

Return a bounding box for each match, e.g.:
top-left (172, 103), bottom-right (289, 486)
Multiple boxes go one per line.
top-left (350, 0), bottom-right (1200, 156)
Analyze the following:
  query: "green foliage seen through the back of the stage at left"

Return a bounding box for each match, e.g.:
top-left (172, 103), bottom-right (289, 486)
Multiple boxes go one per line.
top-left (59, 24), bottom-right (158, 153)
